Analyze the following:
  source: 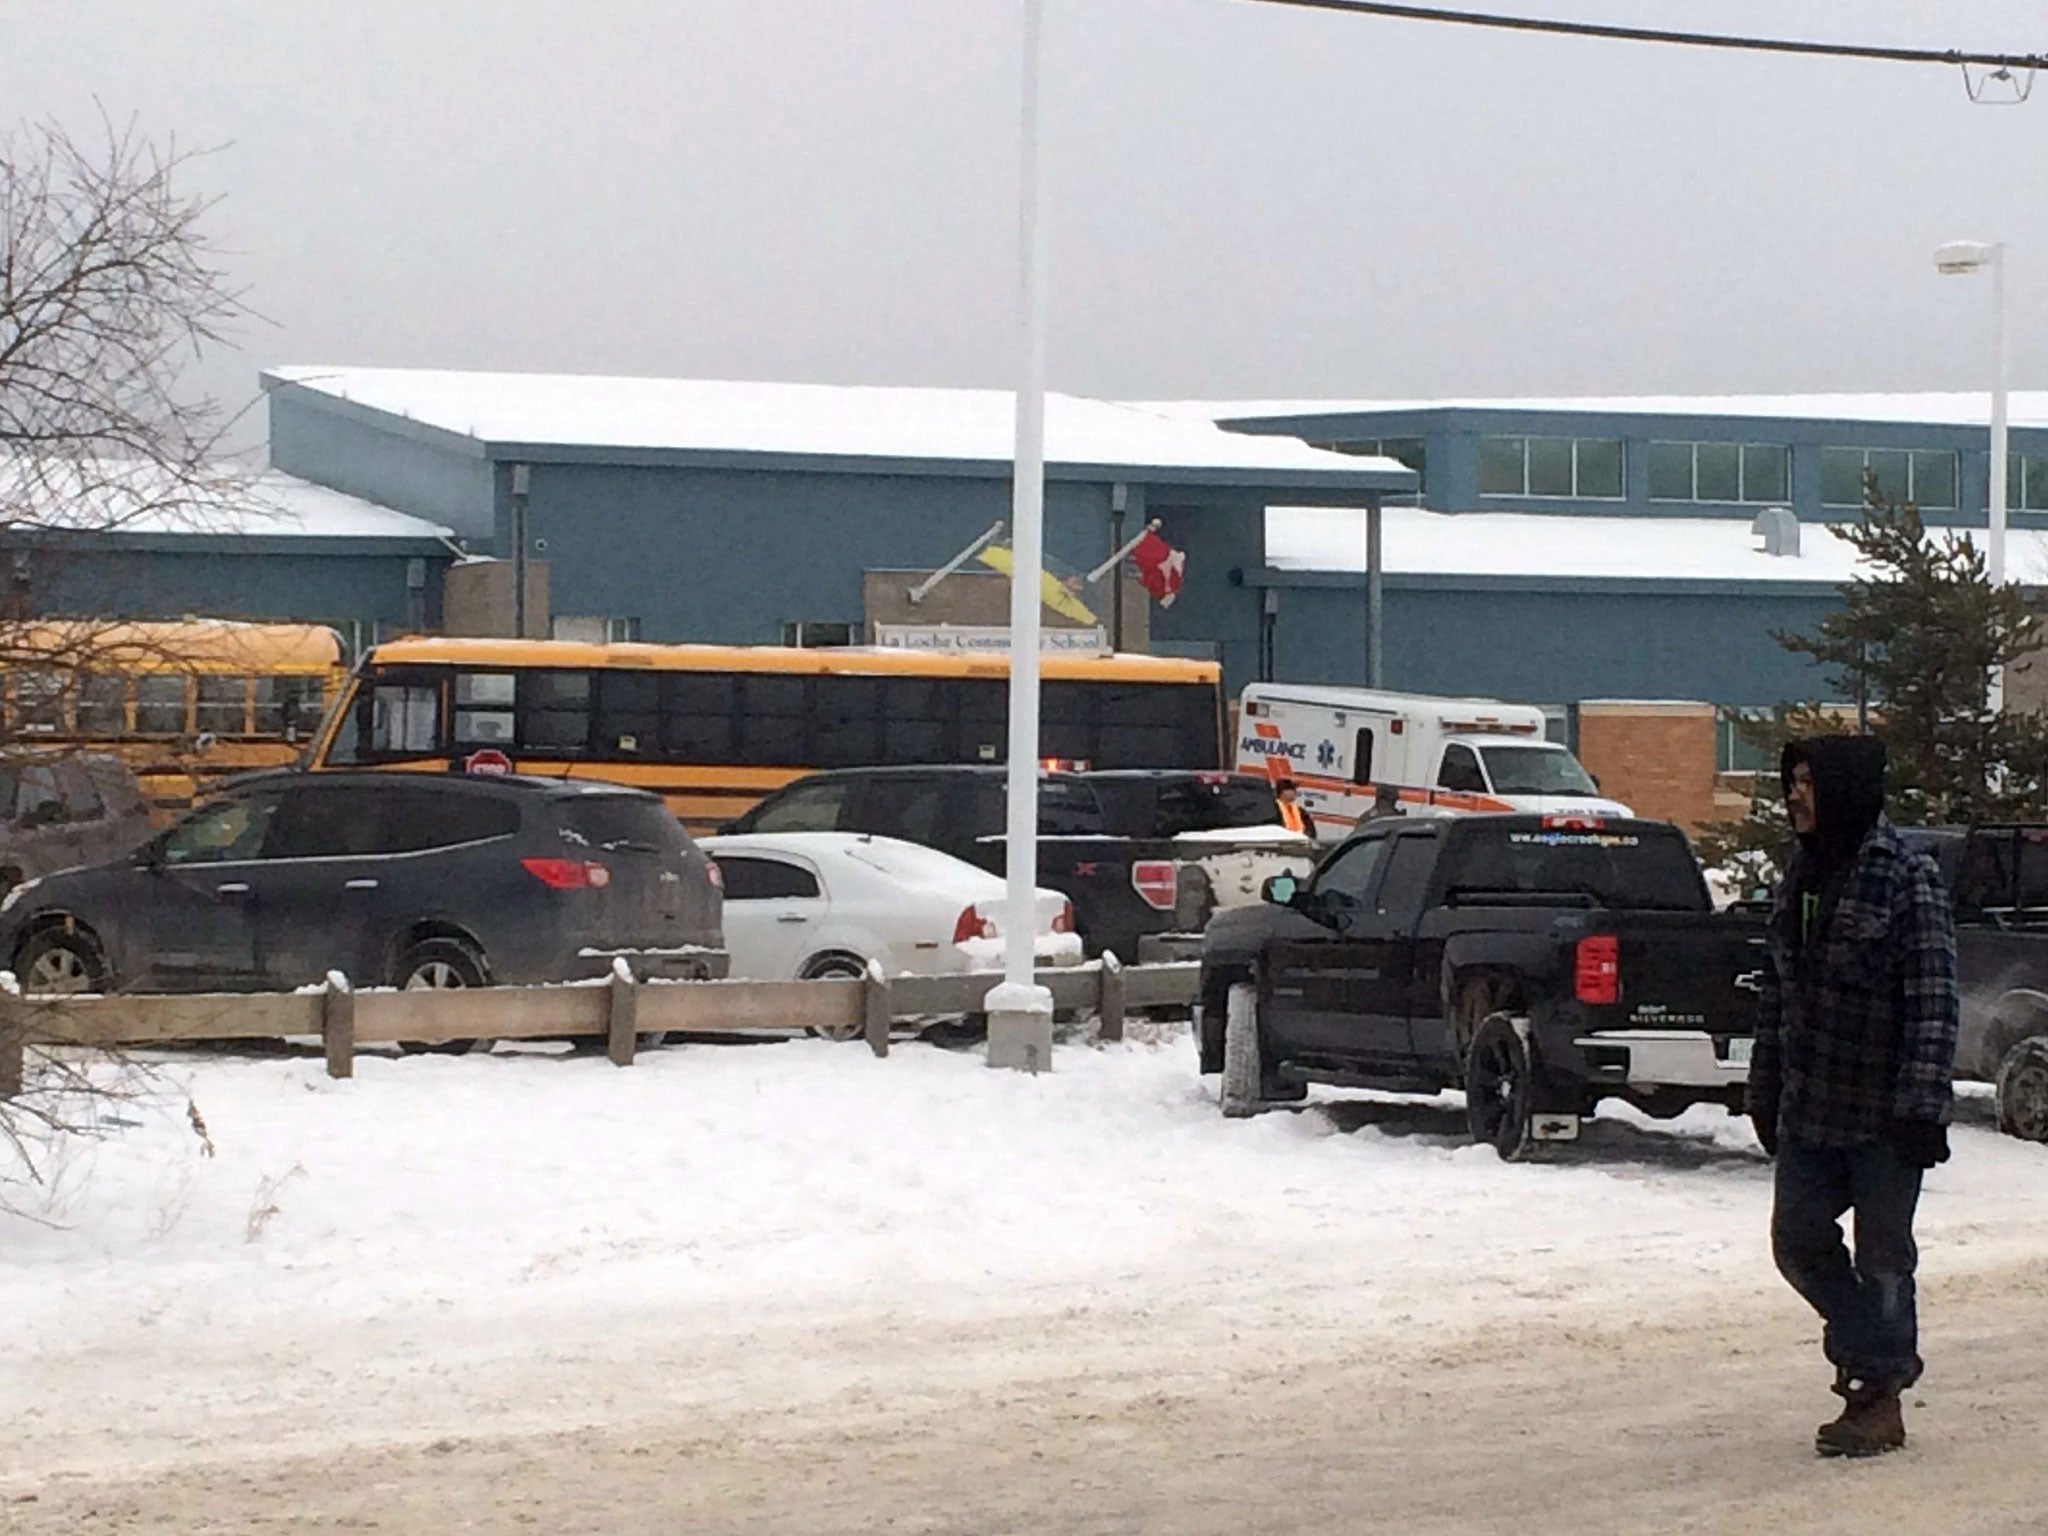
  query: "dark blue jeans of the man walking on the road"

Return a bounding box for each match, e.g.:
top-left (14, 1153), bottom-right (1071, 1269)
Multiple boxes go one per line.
top-left (1772, 1137), bottom-right (1921, 1386)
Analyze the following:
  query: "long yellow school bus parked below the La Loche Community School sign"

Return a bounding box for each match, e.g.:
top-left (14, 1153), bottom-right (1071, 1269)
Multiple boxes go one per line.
top-left (309, 639), bottom-right (1223, 831)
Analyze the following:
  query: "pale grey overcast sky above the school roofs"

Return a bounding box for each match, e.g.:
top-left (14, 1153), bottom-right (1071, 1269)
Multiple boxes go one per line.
top-left (0, 0), bottom-right (2048, 436)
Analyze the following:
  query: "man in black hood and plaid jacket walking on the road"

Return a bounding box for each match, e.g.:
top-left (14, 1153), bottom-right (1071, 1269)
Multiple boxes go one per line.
top-left (1749, 735), bottom-right (1960, 1456)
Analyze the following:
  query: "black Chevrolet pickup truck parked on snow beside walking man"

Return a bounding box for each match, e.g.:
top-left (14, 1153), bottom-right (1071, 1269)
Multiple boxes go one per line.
top-left (1196, 815), bottom-right (1765, 1157)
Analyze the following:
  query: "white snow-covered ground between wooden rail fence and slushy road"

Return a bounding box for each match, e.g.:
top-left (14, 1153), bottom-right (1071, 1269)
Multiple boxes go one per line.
top-left (0, 1034), bottom-right (2048, 1466)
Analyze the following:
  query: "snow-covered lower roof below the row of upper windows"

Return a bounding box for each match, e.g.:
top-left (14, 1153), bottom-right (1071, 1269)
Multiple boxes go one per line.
top-left (1266, 506), bottom-right (2048, 586)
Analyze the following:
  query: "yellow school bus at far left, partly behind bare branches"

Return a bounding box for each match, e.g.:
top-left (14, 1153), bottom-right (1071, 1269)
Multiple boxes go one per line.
top-left (0, 618), bottom-right (348, 819)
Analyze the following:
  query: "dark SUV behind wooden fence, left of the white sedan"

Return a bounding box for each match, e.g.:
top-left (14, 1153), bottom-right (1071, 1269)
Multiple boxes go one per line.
top-left (0, 772), bottom-right (725, 991)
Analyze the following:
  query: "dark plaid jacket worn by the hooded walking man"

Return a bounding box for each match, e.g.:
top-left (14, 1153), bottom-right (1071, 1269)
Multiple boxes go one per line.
top-left (1749, 819), bottom-right (1960, 1147)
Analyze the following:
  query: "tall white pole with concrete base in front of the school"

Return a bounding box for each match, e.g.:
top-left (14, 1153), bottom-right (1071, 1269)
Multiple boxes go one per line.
top-left (983, 0), bottom-right (1053, 1071)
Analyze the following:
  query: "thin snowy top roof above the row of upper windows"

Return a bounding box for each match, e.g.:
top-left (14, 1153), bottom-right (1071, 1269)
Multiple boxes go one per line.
top-left (1133, 389), bottom-right (2048, 426)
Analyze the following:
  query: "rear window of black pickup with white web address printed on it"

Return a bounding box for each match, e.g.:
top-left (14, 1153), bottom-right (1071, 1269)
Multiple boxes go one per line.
top-left (1446, 821), bottom-right (1712, 911)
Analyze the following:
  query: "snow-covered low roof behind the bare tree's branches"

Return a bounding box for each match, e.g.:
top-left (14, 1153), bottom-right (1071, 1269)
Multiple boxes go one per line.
top-left (0, 459), bottom-right (453, 543)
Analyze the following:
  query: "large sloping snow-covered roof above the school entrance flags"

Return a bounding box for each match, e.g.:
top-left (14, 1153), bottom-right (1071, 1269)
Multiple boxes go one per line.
top-left (264, 367), bottom-right (1411, 487)
